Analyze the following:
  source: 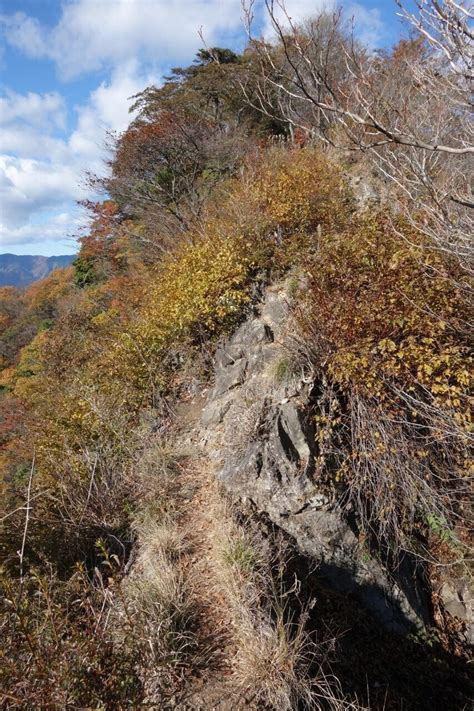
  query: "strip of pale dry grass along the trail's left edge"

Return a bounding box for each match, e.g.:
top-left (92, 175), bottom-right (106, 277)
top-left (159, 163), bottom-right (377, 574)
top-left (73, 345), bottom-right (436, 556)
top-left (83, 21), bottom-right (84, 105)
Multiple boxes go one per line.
top-left (122, 436), bottom-right (203, 700)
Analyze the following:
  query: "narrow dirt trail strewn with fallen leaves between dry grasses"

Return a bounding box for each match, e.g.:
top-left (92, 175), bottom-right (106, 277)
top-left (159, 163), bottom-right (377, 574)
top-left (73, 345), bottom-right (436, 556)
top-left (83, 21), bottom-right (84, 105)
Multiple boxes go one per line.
top-left (165, 400), bottom-right (251, 711)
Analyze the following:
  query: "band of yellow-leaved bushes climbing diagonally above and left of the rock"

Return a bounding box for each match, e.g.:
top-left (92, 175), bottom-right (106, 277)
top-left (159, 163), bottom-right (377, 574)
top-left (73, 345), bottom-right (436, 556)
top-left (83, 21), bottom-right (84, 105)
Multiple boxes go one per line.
top-left (5, 149), bottom-right (349, 490)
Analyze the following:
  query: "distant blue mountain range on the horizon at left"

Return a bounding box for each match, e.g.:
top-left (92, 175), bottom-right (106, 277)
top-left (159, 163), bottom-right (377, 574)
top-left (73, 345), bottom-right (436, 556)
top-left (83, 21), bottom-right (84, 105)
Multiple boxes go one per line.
top-left (0, 254), bottom-right (76, 287)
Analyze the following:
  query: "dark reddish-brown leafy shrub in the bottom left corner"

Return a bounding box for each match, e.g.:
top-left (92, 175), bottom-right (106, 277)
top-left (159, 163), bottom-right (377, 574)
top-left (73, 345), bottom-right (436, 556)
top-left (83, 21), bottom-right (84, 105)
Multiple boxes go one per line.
top-left (1, 568), bottom-right (142, 709)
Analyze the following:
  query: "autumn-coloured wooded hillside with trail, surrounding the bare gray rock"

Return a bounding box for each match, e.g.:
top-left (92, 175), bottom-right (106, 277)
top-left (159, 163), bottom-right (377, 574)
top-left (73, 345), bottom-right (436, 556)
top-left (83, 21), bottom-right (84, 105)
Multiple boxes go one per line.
top-left (0, 0), bottom-right (474, 711)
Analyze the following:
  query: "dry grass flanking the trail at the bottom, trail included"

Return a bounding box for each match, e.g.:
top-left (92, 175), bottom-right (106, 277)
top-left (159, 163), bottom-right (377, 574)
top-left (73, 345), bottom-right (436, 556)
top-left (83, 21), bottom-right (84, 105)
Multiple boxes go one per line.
top-left (1, 414), bottom-right (368, 711)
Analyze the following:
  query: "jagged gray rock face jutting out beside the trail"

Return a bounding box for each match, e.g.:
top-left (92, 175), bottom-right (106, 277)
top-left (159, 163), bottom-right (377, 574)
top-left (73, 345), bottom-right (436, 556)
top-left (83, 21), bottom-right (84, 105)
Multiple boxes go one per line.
top-left (202, 287), bottom-right (428, 632)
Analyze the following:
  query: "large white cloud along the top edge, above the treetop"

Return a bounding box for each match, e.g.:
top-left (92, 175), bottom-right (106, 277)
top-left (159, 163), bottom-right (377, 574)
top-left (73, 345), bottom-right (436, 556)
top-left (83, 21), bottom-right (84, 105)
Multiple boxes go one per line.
top-left (2, 0), bottom-right (241, 79)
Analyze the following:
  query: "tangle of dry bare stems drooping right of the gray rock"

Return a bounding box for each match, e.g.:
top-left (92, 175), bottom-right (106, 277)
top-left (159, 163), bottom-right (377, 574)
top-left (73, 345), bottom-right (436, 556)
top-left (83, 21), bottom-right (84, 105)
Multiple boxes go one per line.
top-left (344, 396), bottom-right (470, 561)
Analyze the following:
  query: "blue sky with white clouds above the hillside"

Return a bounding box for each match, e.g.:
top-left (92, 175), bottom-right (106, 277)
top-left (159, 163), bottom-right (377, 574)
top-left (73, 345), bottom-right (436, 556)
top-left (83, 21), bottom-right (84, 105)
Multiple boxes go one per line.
top-left (0, 0), bottom-right (408, 255)
